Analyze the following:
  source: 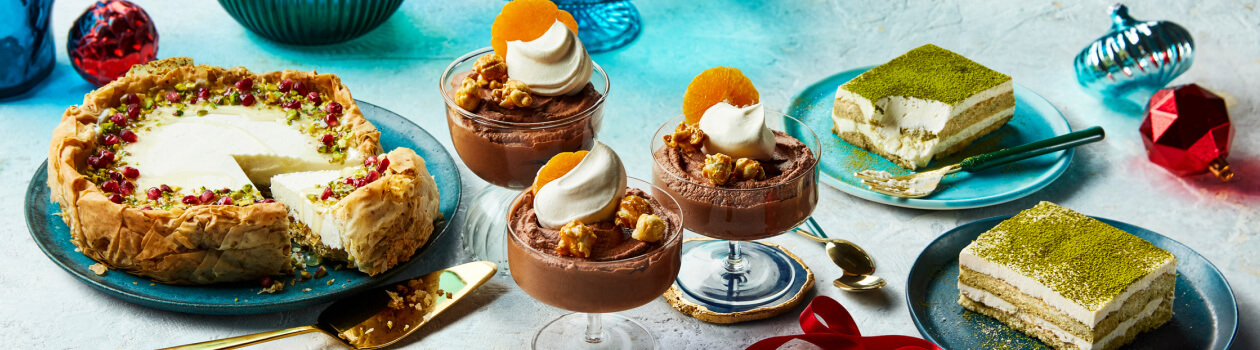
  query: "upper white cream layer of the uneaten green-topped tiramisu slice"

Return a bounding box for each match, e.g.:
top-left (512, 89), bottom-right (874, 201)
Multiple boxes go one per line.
top-left (958, 243), bottom-right (1177, 329)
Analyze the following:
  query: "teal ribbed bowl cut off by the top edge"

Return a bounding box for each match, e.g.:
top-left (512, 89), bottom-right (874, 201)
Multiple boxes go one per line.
top-left (219, 0), bottom-right (402, 45)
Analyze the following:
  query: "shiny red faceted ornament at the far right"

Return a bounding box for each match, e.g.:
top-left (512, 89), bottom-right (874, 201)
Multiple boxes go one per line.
top-left (1139, 84), bottom-right (1234, 181)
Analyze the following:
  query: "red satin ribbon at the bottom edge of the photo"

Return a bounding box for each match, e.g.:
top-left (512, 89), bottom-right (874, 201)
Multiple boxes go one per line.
top-left (747, 296), bottom-right (942, 350)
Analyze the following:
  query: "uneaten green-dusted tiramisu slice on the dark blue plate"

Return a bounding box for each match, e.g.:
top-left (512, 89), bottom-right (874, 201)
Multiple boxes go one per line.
top-left (958, 201), bottom-right (1177, 350)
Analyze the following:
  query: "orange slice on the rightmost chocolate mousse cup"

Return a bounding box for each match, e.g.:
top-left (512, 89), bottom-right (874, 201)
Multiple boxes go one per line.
top-left (683, 67), bottom-right (759, 123)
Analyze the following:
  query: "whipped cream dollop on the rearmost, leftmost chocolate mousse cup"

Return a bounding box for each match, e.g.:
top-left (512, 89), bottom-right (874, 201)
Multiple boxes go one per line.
top-left (504, 20), bottom-right (595, 96)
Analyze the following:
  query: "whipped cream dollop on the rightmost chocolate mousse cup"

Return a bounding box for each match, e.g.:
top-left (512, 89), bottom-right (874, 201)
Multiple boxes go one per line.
top-left (699, 102), bottom-right (775, 160)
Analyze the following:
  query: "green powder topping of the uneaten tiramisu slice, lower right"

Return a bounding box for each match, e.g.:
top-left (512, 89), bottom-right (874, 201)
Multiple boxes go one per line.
top-left (970, 201), bottom-right (1176, 311)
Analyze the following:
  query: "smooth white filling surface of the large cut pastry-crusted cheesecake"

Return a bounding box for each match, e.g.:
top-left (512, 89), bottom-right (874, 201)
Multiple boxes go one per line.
top-left (122, 106), bottom-right (363, 190)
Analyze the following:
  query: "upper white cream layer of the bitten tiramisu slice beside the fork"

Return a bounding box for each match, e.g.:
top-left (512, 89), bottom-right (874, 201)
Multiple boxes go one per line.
top-left (835, 81), bottom-right (1014, 133)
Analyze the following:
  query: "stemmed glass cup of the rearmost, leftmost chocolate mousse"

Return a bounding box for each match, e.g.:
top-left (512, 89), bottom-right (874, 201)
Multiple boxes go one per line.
top-left (438, 47), bottom-right (609, 266)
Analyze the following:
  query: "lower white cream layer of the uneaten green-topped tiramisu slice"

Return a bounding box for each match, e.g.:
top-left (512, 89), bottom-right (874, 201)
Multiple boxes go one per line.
top-left (958, 283), bottom-right (1164, 350)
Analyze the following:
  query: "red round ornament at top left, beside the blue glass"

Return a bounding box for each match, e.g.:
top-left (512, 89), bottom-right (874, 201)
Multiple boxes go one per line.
top-left (66, 0), bottom-right (158, 87)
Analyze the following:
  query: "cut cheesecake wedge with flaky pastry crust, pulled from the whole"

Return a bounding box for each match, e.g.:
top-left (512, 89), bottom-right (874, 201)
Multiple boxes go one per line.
top-left (271, 147), bottom-right (441, 274)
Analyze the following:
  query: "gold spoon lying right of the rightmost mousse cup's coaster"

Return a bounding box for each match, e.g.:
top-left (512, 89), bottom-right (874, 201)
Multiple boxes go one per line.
top-left (794, 217), bottom-right (887, 292)
